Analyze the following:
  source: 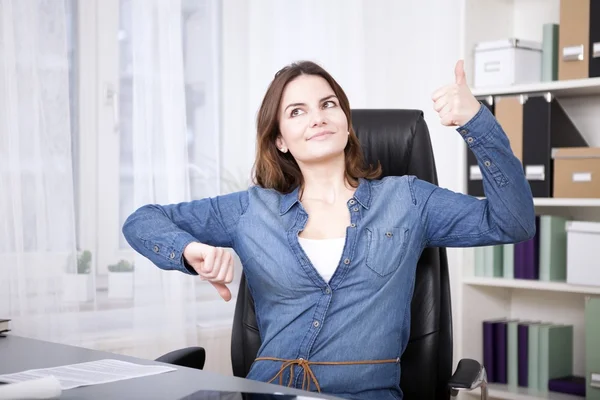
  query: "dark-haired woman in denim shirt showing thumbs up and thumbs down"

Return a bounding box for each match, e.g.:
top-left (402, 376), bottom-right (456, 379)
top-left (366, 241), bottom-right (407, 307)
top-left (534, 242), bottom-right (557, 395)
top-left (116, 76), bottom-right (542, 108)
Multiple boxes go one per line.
top-left (123, 61), bottom-right (535, 399)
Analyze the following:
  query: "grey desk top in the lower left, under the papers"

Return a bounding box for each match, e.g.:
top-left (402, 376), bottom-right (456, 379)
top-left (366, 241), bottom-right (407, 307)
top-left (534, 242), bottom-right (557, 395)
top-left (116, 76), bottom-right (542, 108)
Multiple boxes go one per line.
top-left (0, 334), bottom-right (334, 400)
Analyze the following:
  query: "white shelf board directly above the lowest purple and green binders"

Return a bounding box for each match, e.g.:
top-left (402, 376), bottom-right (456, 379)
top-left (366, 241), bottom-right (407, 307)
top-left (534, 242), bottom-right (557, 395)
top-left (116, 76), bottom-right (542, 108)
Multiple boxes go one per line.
top-left (463, 276), bottom-right (600, 295)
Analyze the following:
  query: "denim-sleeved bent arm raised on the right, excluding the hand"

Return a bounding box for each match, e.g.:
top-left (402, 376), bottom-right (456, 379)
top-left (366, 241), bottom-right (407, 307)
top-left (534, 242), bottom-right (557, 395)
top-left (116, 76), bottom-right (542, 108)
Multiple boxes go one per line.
top-left (411, 107), bottom-right (536, 247)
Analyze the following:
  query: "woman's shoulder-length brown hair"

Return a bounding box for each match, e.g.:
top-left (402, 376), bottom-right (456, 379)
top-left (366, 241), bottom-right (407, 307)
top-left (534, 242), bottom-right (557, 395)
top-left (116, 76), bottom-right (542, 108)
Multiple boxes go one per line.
top-left (254, 61), bottom-right (381, 193)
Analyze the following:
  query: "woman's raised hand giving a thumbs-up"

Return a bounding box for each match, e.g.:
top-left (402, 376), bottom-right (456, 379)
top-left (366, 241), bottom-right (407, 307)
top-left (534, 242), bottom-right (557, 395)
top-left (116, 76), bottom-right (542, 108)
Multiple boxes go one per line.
top-left (432, 60), bottom-right (481, 126)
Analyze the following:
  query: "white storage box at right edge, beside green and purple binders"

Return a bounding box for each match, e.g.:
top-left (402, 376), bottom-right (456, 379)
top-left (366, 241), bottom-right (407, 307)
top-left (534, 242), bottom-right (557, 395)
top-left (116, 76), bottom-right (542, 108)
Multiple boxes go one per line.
top-left (566, 221), bottom-right (600, 286)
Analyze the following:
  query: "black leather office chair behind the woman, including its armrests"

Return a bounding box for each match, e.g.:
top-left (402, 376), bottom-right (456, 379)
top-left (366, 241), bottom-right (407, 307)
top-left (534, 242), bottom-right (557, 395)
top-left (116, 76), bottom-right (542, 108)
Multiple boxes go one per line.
top-left (158, 110), bottom-right (487, 400)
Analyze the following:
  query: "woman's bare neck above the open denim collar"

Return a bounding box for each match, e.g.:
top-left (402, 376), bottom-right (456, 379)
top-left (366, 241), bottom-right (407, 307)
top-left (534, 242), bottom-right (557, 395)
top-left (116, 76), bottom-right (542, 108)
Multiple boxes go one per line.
top-left (300, 155), bottom-right (355, 204)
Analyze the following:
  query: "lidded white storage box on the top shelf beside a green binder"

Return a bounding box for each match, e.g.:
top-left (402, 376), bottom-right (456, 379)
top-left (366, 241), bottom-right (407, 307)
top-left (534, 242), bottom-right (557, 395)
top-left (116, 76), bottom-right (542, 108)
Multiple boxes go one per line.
top-left (474, 39), bottom-right (542, 88)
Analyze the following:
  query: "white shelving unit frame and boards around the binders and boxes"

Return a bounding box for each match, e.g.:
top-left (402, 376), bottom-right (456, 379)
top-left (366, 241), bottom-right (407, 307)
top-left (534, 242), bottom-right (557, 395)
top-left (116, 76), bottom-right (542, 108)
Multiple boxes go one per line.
top-left (451, 0), bottom-right (600, 400)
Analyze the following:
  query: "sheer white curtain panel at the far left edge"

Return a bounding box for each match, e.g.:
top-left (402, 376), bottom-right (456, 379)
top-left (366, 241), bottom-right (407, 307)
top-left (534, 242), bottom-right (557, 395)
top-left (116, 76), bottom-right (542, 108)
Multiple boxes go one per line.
top-left (0, 0), bottom-right (77, 339)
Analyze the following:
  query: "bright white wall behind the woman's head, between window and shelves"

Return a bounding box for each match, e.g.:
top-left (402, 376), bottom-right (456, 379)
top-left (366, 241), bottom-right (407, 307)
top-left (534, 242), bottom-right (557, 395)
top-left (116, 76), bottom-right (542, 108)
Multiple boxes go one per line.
top-left (222, 0), bottom-right (465, 368)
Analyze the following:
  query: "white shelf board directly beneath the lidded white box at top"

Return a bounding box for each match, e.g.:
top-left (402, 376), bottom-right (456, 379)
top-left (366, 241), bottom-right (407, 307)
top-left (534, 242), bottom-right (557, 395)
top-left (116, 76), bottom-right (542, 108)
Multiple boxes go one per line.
top-left (472, 78), bottom-right (600, 97)
